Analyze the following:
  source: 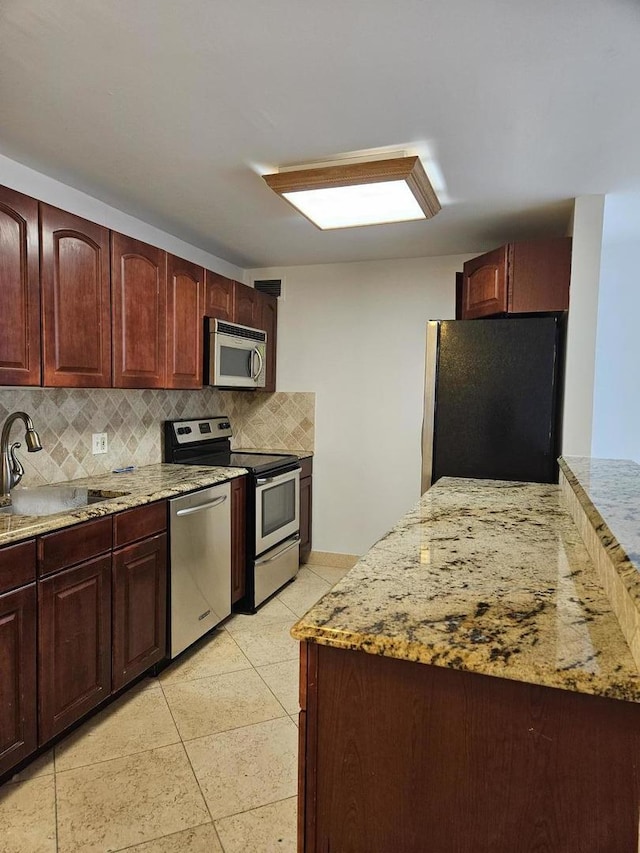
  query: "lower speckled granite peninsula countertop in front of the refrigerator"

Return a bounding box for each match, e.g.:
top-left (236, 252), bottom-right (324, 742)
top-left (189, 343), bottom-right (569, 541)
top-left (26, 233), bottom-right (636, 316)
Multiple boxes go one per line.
top-left (292, 478), bottom-right (640, 702)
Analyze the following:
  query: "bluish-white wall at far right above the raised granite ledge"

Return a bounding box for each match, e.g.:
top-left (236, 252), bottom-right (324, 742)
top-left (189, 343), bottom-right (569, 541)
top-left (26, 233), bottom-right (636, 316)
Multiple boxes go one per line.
top-left (592, 193), bottom-right (640, 462)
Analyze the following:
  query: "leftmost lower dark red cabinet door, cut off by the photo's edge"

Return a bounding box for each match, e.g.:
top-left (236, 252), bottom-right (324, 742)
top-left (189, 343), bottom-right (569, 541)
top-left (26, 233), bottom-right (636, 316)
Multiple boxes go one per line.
top-left (0, 583), bottom-right (37, 775)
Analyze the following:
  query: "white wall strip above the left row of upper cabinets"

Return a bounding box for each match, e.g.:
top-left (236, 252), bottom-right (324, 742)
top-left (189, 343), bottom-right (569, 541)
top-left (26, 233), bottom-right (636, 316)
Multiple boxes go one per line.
top-left (0, 154), bottom-right (244, 281)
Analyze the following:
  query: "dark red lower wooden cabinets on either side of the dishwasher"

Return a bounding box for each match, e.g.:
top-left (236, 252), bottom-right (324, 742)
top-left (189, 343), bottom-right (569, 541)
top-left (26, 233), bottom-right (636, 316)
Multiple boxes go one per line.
top-left (0, 500), bottom-right (172, 772)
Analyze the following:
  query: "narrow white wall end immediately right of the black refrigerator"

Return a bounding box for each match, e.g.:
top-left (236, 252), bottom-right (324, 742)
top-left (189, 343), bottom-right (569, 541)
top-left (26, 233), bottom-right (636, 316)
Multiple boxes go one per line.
top-left (562, 195), bottom-right (604, 456)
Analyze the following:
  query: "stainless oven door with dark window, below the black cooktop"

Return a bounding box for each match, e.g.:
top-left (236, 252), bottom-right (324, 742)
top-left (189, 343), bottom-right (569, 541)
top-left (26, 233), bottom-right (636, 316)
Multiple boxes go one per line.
top-left (255, 468), bottom-right (300, 556)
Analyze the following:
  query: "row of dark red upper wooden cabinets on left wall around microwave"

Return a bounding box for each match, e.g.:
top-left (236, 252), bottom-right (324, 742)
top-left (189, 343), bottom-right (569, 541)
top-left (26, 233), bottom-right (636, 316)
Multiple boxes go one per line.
top-left (0, 181), bottom-right (277, 391)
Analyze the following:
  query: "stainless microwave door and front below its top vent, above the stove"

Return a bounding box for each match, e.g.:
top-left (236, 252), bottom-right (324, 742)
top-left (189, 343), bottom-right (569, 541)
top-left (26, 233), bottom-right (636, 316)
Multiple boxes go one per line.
top-left (209, 332), bottom-right (266, 388)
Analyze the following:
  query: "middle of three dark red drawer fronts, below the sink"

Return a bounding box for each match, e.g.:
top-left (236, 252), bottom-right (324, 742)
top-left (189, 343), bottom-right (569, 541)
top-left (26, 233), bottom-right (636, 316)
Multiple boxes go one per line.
top-left (38, 515), bottom-right (112, 577)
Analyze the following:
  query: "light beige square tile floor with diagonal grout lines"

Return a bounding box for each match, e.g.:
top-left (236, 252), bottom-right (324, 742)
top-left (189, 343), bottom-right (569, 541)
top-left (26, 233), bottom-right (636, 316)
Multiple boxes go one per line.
top-left (0, 565), bottom-right (347, 853)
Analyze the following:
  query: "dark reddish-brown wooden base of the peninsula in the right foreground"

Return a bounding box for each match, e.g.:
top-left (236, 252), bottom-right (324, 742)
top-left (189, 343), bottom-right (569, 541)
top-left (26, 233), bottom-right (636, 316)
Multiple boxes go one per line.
top-left (298, 642), bottom-right (640, 853)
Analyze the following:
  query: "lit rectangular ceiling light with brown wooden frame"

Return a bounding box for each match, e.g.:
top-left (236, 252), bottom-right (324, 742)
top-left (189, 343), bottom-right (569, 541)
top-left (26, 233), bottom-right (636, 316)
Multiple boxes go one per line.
top-left (263, 157), bottom-right (440, 230)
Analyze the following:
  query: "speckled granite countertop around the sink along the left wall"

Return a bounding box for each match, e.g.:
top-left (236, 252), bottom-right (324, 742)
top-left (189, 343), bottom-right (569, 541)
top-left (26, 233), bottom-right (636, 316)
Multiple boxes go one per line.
top-left (0, 463), bottom-right (247, 546)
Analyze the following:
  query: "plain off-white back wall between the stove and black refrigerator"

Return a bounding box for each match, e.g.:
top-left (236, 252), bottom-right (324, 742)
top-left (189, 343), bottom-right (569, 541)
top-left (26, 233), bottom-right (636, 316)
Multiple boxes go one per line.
top-left (251, 255), bottom-right (471, 554)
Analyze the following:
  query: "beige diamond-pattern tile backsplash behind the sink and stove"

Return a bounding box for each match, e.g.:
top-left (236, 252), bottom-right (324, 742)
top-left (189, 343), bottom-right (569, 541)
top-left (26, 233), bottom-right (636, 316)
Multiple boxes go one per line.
top-left (0, 387), bottom-right (315, 486)
